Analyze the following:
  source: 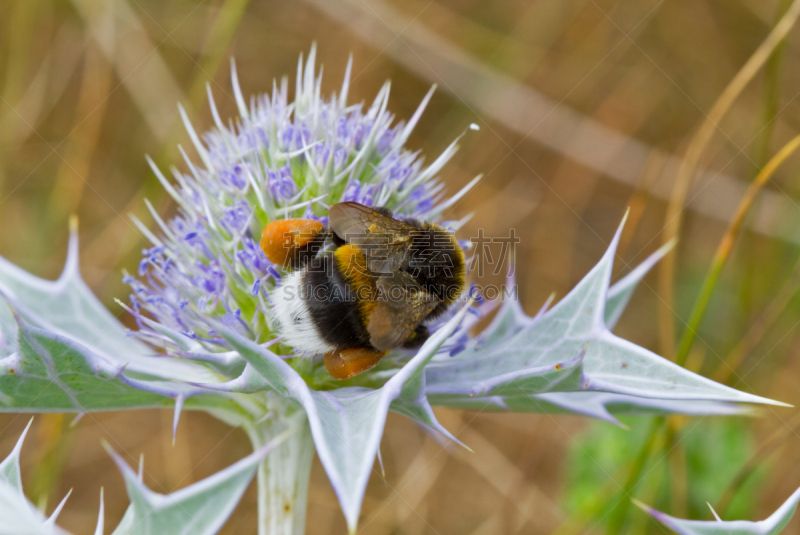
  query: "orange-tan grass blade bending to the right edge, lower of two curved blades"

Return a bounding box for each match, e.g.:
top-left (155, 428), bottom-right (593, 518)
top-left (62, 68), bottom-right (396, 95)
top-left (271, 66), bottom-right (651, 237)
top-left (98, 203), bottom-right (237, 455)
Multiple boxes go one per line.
top-left (675, 136), bottom-right (800, 365)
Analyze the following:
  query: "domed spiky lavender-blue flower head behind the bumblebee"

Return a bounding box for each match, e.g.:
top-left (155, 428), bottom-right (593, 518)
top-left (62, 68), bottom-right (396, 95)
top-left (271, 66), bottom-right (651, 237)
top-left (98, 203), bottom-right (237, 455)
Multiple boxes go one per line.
top-left (124, 48), bottom-right (474, 368)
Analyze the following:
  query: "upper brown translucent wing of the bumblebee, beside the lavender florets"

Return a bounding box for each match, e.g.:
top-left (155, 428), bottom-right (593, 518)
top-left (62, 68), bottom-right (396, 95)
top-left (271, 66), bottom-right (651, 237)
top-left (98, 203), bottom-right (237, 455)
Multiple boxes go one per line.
top-left (328, 202), bottom-right (417, 274)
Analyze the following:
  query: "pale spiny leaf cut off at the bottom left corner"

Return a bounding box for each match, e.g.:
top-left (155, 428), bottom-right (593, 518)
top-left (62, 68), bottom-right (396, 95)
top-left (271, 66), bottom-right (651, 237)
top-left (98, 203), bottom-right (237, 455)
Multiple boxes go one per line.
top-left (0, 420), bottom-right (69, 535)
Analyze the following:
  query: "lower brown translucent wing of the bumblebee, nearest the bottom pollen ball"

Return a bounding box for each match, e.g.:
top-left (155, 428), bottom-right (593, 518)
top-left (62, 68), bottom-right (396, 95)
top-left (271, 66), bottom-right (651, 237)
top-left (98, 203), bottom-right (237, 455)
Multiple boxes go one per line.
top-left (367, 272), bottom-right (439, 351)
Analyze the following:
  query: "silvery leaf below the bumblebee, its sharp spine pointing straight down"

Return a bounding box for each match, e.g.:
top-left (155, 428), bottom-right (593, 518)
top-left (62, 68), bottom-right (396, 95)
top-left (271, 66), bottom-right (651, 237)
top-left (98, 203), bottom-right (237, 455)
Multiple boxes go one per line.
top-left (207, 305), bottom-right (469, 531)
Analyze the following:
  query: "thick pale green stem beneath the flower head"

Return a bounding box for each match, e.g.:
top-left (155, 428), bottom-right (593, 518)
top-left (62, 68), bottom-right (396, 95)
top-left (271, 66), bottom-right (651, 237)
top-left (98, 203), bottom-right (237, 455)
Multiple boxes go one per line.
top-left (245, 396), bottom-right (314, 535)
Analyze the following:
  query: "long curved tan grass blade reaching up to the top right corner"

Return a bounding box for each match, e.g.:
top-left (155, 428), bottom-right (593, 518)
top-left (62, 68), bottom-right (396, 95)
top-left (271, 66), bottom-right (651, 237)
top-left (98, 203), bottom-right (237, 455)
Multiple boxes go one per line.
top-left (659, 0), bottom-right (800, 363)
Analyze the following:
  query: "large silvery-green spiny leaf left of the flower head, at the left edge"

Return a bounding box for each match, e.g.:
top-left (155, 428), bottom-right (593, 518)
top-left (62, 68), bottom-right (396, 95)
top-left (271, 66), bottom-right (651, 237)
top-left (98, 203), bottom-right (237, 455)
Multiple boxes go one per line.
top-left (0, 225), bottom-right (235, 412)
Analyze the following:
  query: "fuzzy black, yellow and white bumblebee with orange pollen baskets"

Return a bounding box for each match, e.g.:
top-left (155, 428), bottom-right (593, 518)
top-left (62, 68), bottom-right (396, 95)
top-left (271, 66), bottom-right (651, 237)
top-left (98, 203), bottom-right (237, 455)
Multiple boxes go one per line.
top-left (261, 202), bottom-right (465, 379)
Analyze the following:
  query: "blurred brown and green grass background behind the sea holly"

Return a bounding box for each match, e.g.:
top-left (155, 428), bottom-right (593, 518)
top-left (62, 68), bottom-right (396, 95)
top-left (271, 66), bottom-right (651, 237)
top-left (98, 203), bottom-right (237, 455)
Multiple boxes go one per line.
top-left (0, 0), bottom-right (800, 535)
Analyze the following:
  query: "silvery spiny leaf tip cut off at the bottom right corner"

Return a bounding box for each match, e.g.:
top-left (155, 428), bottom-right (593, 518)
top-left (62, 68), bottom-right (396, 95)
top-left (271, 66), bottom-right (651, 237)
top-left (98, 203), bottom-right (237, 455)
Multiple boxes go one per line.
top-left (634, 489), bottom-right (800, 535)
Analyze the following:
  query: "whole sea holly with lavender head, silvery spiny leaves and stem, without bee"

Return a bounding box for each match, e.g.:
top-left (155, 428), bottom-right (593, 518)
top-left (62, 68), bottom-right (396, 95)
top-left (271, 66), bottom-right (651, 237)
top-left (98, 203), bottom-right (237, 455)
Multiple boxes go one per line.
top-left (0, 49), bottom-right (778, 535)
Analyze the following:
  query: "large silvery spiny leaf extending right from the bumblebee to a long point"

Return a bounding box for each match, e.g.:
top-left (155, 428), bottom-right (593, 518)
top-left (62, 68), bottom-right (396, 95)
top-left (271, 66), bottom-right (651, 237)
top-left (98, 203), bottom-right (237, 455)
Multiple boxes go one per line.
top-left (426, 216), bottom-right (781, 405)
